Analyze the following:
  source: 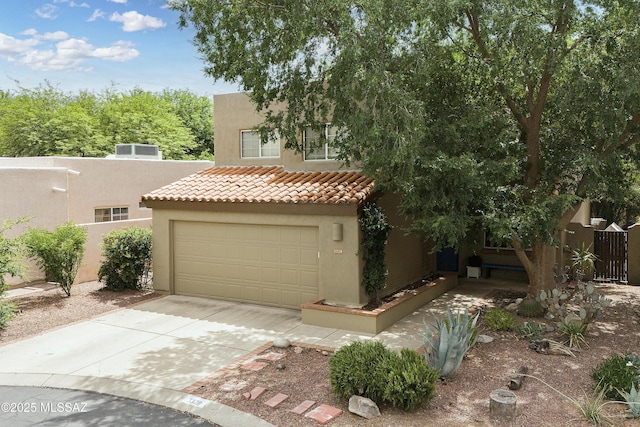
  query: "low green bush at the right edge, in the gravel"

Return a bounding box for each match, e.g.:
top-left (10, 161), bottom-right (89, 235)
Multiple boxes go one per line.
top-left (591, 354), bottom-right (640, 400)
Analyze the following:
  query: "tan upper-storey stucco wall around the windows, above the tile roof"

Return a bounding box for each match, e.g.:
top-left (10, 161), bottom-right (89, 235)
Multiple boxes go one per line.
top-left (213, 93), bottom-right (342, 171)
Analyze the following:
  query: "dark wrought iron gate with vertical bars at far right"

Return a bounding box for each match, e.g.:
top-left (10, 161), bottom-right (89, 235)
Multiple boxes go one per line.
top-left (593, 230), bottom-right (629, 282)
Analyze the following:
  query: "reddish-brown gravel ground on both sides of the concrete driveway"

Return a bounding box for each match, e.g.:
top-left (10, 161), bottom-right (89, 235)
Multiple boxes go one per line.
top-left (5, 282), bottom-right (640, 427)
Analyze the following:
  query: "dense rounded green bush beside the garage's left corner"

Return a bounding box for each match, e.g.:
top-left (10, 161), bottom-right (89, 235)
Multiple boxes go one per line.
top-left (98, 227), bottom-right (152, 291)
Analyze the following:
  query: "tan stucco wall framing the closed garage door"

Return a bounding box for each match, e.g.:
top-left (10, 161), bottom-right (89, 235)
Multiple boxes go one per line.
top-left (147, 204), bottom-right (367, 305)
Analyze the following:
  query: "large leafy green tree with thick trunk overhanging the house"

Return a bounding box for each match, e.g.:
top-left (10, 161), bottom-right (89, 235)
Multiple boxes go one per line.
top-left (172, 0), bottom-right (640, 294)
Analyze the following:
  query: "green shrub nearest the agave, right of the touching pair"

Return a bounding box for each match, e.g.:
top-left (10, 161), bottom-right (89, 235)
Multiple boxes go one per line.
top-left (384, 348), bottom-right (438, 411)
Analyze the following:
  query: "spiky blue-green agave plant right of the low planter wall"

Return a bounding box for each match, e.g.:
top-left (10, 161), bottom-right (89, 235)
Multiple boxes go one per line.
top-left (422, 309), bottom-right (479, 377)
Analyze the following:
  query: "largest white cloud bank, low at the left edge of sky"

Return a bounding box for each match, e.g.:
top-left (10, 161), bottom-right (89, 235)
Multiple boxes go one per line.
top-left (0, 29), bottom-right (140, 71)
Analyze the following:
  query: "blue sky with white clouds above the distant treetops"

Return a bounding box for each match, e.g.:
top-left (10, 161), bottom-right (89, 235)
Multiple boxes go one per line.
top-left (0, 0), bottom-right (239, 96)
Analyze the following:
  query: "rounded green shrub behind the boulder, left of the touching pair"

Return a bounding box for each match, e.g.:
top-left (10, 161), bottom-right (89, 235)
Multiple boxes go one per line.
top-left (329, 341), bottom-right (397, 403)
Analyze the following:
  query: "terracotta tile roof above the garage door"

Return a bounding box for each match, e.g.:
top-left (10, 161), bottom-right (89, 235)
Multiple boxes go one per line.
top-left (142, 166), bottom-right (374, 204)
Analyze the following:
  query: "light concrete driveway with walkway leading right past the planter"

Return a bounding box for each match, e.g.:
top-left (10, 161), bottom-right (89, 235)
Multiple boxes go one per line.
top-left (0, 280), bottom-right (526, 427)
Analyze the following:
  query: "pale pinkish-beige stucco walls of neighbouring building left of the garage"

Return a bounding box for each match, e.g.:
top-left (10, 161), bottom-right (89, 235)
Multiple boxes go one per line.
top-left (0, 157), bottom-right (213, 285)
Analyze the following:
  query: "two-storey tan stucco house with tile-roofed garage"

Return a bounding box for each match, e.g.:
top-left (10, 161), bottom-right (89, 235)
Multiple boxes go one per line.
top-left (142, 93), bottom-right (436, 309)
